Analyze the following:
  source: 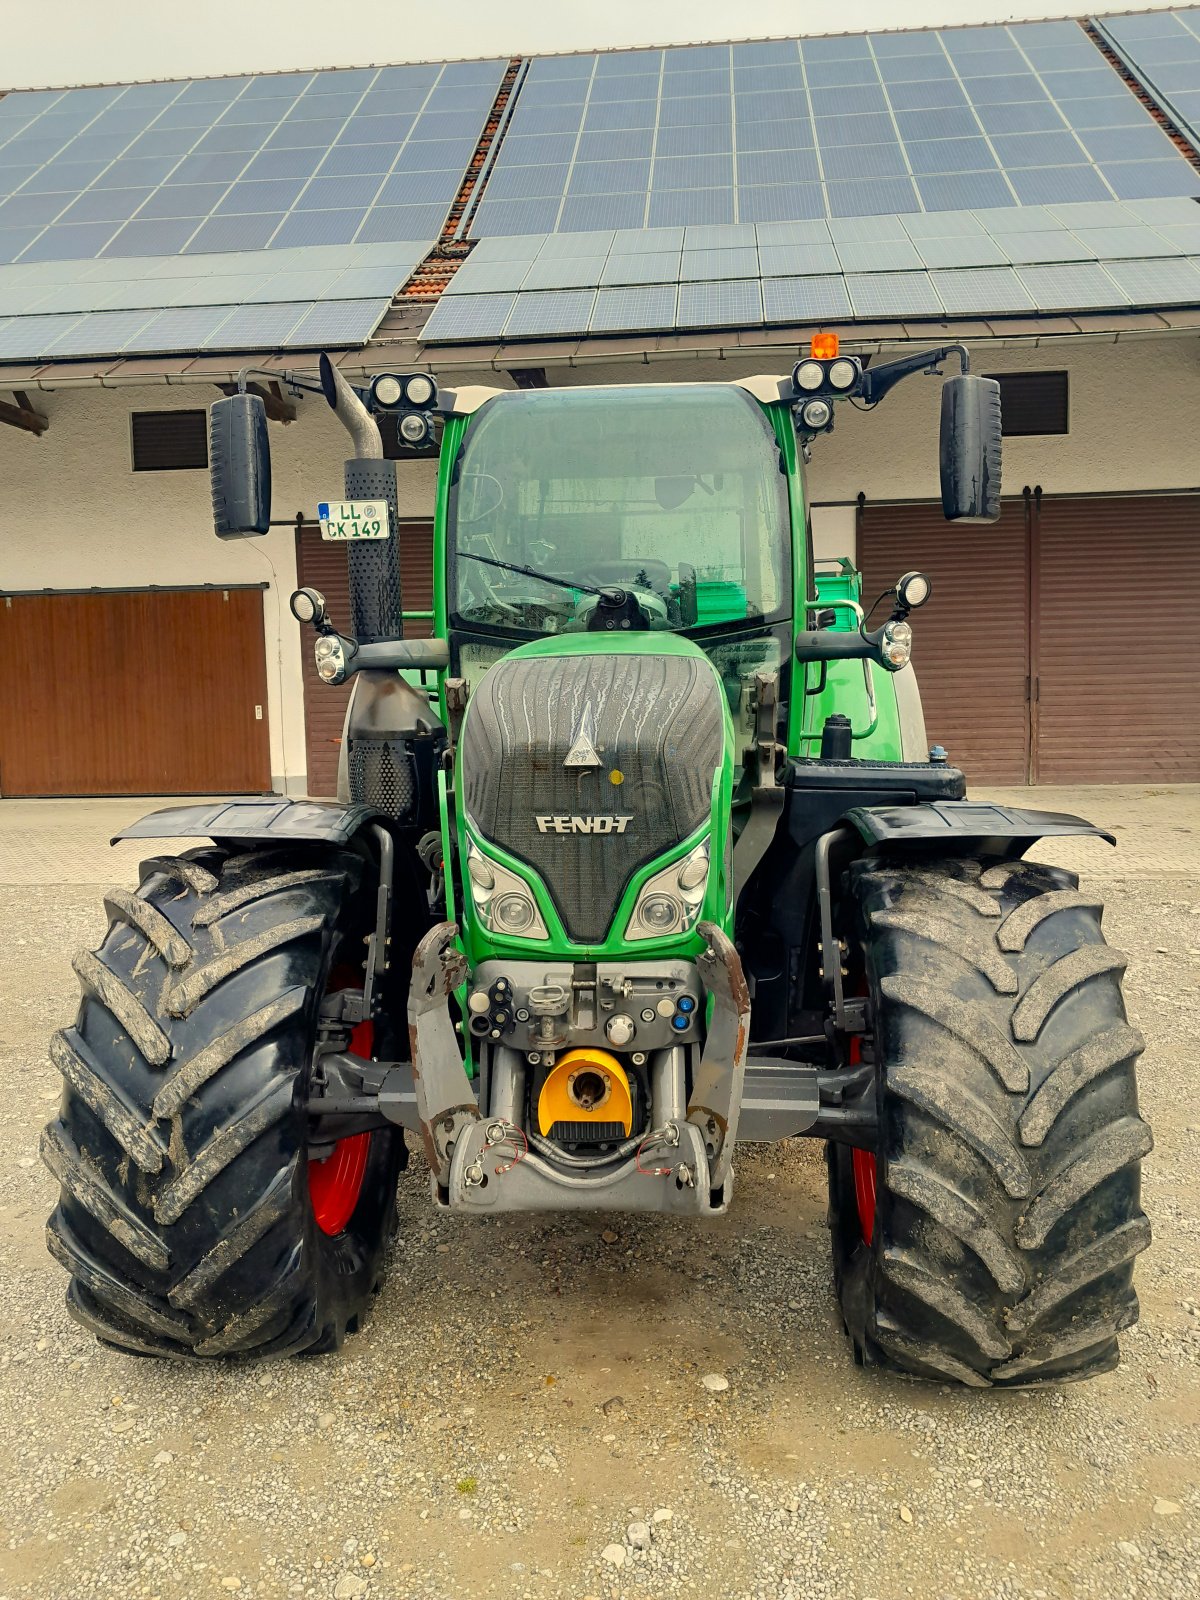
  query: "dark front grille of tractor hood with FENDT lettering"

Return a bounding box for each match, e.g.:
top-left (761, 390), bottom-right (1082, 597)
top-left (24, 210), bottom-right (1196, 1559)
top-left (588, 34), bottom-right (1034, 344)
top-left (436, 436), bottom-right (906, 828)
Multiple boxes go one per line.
top-left (458, 632), bottom-right (731, 946)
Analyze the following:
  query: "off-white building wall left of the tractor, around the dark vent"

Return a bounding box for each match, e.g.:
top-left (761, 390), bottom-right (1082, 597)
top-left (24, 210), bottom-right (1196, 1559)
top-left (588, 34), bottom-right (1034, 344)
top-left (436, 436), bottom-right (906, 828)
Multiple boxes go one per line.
top-left (0, 386), bottom-right (437, 794)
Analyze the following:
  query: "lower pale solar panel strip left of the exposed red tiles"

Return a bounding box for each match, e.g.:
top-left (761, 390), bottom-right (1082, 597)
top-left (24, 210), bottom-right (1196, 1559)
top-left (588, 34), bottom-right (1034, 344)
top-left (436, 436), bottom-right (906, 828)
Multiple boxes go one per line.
top-left (0, 240), bottom-right (429, 362)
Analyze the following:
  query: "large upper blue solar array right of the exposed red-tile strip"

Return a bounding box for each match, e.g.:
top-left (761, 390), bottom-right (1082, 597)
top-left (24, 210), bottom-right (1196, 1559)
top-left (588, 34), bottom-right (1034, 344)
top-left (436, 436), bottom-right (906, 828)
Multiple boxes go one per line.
top-left (470, 21), bottom-right (1200, 237)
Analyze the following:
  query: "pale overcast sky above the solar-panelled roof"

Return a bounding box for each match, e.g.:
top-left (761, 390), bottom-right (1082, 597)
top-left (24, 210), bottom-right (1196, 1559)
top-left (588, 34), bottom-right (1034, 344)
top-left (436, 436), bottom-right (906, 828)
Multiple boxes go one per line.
top-left (0, 0), bottom-right (1171, 90)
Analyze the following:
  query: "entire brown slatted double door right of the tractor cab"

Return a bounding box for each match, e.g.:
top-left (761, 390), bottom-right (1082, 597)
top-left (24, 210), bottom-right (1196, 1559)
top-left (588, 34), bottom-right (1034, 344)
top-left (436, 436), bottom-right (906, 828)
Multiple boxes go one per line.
top-left (859, 494), bottom-right (1200, 784)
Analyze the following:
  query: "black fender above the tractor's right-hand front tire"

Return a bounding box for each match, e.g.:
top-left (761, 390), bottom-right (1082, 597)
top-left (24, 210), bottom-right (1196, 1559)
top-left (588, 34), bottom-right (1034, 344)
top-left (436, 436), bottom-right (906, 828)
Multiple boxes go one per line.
top-left (842, 800), bottom-right (1117, 856)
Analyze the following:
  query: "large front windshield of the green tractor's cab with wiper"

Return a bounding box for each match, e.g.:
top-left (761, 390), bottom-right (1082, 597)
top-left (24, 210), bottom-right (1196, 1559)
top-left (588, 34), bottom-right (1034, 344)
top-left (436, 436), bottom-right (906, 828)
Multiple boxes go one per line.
top-left (448, 384), bottom-right (790, 634)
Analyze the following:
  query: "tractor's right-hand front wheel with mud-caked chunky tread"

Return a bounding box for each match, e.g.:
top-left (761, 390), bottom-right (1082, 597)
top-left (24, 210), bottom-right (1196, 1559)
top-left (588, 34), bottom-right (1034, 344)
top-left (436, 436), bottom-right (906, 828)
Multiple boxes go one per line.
top-left (827, 859), bottom-right (1152, 1387)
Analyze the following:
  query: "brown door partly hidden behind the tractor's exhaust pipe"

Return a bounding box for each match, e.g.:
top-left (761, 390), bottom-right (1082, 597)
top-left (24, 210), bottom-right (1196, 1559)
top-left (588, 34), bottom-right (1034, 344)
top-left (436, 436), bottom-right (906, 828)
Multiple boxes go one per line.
top-left (296, 522), bottom-right (434, 795)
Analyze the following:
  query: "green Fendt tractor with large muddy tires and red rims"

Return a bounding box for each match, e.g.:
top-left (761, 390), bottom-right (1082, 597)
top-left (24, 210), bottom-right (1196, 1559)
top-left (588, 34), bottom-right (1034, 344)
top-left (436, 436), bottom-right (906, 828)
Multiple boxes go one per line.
top-left (43, 334), bottom-right (1150, 1386)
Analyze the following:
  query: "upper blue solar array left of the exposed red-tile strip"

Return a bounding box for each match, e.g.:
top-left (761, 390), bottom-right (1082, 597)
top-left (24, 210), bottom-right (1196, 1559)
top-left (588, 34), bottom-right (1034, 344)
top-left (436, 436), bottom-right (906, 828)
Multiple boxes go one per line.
top-left (0, 61), bottom-right (507, 267)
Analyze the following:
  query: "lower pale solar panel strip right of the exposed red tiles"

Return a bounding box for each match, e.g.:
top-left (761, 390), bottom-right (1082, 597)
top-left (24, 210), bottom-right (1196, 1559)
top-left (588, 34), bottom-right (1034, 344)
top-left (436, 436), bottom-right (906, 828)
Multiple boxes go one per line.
top-left (422, 198), bottom-right (1200, 344)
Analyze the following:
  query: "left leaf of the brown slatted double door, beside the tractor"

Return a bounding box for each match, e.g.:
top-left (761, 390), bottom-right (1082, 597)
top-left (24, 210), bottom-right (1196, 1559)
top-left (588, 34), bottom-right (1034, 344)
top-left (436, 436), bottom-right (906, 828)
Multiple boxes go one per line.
top-left (859, 501), bottom-right (1029, 784)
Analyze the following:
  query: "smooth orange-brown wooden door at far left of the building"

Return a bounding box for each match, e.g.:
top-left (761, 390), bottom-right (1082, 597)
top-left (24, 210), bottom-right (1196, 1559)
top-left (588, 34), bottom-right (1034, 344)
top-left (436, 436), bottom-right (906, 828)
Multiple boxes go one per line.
top-left (0, 587), bottom-right (270, 797)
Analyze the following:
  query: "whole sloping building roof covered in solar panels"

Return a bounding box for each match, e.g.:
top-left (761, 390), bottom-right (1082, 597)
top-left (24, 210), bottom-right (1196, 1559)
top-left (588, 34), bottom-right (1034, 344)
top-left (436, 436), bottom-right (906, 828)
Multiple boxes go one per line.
top-left (0, 11), bottom-right (1200, 371)
